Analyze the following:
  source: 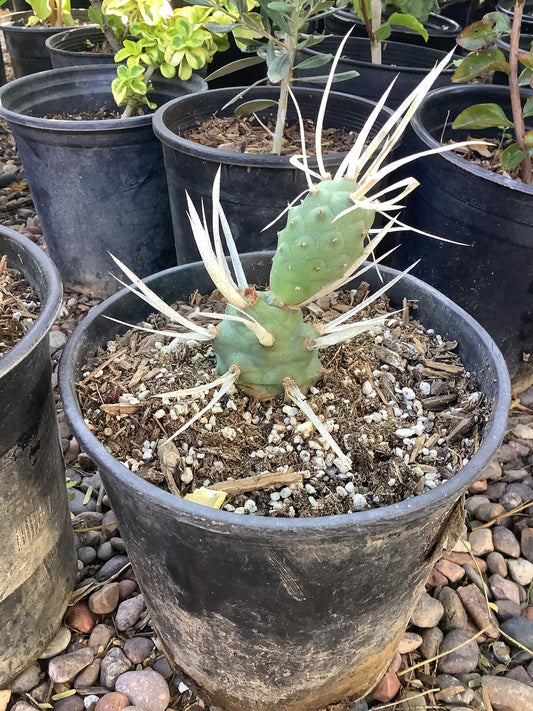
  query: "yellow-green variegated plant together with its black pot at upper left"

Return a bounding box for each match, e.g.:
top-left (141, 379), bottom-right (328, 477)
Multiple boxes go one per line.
top-left (0, 0), bottom-right (243, 296)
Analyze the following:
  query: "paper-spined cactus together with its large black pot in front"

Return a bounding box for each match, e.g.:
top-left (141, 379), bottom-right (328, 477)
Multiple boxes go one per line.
top-left (60, 54), bottom-right (509, 711)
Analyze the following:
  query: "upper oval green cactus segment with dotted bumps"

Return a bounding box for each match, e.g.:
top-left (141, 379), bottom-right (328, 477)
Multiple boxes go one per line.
top-left (270, 178), bottom-right (375, 305)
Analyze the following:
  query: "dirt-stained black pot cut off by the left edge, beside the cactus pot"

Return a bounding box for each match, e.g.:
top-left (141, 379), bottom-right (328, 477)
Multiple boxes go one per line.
top-left (0, 227), bottom-right (77, 689)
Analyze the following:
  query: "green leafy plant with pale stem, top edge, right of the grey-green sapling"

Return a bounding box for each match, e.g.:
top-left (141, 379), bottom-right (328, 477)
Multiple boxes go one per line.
top-left (353, 0), bottom-right (439, 64)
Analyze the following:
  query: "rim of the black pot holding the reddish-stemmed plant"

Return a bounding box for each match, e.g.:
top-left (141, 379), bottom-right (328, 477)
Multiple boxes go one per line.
top-left (411, 84), bottom-right (533, 195)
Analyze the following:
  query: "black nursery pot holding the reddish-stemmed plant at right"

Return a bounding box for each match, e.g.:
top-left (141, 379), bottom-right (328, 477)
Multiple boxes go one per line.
top-left (395, 85), bottom-right (533, 386)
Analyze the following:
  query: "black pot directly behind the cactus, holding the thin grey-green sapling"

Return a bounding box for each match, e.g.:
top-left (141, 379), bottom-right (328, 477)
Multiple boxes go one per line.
top-left (153, 86), bottom-right (391, 264)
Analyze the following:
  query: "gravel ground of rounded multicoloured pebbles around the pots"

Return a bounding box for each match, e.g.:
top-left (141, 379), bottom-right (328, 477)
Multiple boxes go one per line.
top-left (0, 50), bottom-right (533, 711)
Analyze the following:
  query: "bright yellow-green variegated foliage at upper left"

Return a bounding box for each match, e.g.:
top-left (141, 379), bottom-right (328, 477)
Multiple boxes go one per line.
top-left (89, 0), bottom-right (233, 117)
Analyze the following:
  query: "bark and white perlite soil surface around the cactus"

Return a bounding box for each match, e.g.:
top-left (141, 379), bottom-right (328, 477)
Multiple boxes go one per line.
top-left (78, 283), bottom-right (490, 517)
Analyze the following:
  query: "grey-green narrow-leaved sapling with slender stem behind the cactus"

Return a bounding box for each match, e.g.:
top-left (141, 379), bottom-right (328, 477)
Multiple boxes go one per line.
top-left (189, 0), bottom-right (357, 155)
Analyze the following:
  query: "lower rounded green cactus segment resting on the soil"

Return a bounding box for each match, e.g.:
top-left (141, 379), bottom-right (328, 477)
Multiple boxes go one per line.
top-left (212, 292), bottom-right (322, 399)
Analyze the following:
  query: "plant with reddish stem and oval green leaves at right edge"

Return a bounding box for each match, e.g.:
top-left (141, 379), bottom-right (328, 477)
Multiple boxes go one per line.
top-left (452, 0), bottom-right (533, 184)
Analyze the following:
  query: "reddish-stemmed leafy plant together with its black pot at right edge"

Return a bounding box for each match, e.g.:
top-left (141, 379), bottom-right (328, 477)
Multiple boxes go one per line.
top-left (390, 2), bottom-right (533, 385)
